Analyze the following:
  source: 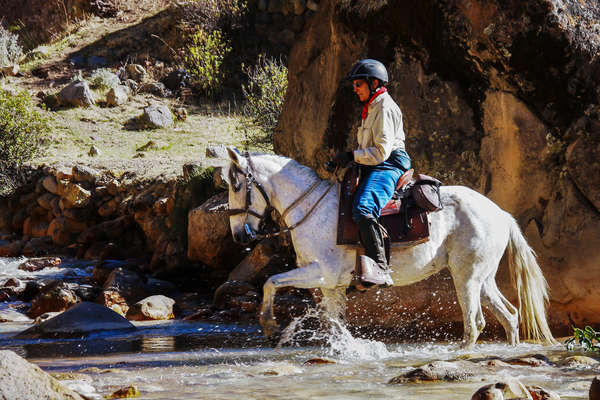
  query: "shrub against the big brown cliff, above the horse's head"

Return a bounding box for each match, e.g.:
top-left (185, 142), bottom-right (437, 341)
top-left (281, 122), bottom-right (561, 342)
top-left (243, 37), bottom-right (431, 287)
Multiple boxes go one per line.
top-left (242, 56), bottom-right (288, 148)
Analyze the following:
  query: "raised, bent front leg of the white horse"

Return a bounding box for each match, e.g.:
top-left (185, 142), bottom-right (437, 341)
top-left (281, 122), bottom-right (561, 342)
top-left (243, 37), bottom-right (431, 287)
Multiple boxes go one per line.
top-left (259, 261), bottom-right (339, 338)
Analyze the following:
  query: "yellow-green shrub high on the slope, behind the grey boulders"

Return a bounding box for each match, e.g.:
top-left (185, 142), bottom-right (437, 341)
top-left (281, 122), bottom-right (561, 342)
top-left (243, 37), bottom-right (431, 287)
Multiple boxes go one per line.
top-left (185, 29), bottom-right (231, 96)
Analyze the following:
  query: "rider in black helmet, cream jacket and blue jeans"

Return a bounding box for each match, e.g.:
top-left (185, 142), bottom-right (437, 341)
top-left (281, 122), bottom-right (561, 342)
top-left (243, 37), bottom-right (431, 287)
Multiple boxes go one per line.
top-left (334, 59), bottom-right (411, 289)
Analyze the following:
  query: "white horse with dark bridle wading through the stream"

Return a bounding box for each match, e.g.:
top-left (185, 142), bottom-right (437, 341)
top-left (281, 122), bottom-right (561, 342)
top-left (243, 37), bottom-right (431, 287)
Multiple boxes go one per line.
top-left (227, 148), bottom-right (555, 347)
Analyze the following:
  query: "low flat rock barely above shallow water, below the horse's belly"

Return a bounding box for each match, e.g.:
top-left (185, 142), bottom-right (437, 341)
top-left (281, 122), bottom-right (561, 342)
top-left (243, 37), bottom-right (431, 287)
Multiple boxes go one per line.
top-left (388, 361), bottom-right (481, 384)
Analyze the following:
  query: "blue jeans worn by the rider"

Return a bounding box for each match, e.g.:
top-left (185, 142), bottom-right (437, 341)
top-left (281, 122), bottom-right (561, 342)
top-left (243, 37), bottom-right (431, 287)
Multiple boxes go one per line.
top-left (352, 150), bottom-right (411, 221)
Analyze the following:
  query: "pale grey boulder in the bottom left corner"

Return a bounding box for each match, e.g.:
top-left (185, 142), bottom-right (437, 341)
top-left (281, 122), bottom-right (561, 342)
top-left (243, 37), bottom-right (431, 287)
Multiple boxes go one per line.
top-left (0, 350), bottom-right (83, 400)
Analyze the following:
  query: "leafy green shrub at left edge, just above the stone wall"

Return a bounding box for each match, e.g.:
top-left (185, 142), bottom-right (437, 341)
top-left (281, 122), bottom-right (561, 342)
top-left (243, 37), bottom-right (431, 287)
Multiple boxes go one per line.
top-left (0, 90), bottom-right (50, 166)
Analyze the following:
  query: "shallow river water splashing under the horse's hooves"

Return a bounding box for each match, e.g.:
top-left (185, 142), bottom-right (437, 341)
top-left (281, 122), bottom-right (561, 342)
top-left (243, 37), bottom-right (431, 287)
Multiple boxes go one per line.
top-left (0, 263), bottom-right (600, 400)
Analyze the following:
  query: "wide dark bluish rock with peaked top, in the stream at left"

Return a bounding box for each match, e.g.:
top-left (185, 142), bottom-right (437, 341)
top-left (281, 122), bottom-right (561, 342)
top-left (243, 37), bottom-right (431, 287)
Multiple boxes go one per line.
top-left (16, 302), bottom-right (135, 339)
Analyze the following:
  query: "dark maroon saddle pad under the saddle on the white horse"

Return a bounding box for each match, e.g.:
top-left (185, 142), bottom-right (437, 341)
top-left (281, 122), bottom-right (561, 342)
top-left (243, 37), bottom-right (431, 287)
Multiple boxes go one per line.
top-left (337, 184), bottom-right (429, 246)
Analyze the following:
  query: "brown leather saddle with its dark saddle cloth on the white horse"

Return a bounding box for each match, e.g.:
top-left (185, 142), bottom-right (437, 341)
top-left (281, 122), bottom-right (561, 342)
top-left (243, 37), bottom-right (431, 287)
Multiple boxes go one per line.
top-left (337, 165), bottom-right (429, 247)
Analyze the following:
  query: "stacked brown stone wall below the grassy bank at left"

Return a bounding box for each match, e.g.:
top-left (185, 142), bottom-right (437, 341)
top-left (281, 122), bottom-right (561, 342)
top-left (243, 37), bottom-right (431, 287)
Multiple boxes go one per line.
top-left (0, 165), bottom-right (185, 270)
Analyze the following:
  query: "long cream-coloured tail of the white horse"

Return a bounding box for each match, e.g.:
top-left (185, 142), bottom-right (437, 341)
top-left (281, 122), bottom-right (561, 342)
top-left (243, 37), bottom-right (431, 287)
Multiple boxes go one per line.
top-left (508, 216), bottom-right (556, 344)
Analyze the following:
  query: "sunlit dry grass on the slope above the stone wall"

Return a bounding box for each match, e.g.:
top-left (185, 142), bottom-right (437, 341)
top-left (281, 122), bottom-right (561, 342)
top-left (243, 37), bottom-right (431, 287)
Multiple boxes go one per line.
top-left (0, 12), bottom-right (270, 177)
